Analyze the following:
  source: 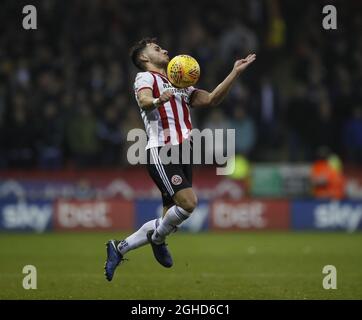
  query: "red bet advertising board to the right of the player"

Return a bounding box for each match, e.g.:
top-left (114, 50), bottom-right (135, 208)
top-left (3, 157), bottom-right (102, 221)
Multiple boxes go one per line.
top-left (210, 200), bottom-right (290, 231)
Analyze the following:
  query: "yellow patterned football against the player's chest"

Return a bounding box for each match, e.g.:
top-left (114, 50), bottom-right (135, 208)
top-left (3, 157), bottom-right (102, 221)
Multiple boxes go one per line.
top-left (167, 54), bottom-right (200, 88)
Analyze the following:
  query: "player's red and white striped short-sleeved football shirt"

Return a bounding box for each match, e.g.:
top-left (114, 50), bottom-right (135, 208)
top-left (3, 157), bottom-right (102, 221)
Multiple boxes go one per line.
top-left (134, 71), bottom-right (196, 149)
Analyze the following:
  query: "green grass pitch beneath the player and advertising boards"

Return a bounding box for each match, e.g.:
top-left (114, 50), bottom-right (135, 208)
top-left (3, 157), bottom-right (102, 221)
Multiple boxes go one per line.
top-left (0, 232), bottom-right (362, 299)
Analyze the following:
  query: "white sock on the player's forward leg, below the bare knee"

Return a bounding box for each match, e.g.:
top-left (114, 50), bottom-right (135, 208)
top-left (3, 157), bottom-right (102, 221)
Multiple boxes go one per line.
top-left (152, 205), bottom-right (191, 243)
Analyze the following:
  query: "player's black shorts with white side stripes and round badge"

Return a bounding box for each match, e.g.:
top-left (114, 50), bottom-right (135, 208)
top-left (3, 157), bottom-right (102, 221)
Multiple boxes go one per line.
top-left (147, 140), bottom-right (192, 207)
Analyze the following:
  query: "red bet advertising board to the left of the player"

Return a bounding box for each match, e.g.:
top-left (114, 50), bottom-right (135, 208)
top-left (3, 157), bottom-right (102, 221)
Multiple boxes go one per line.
top-left (54, 200), bottom-right (134, 231)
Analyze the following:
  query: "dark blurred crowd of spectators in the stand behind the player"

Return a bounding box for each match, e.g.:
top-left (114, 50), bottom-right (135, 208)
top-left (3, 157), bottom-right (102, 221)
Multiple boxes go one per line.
top-left (0, 0), bottom-right (362, 169)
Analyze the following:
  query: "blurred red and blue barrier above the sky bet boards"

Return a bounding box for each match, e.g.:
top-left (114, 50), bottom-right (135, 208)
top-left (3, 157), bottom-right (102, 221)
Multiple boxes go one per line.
top-left (0, 165), bottom-right (246, 201)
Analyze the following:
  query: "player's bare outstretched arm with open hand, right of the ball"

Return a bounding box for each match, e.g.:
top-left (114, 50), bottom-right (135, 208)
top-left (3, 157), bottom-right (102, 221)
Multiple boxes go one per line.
top-left (191, 54), bottom-right (256, 108)
